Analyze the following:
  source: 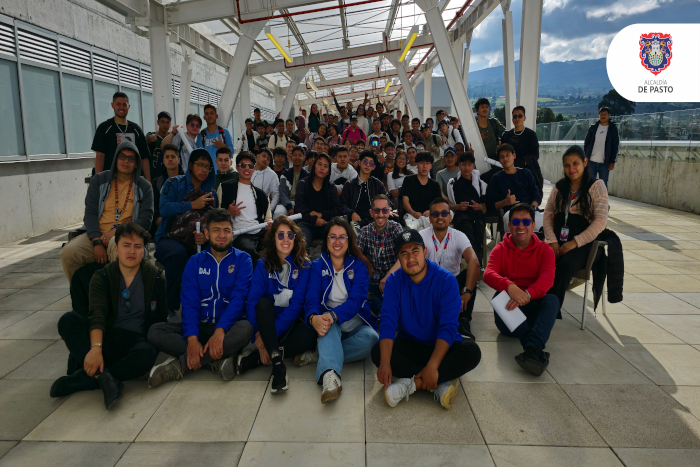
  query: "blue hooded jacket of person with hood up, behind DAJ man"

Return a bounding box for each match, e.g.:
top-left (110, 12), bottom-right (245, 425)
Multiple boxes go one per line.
top-left (156, 148), bottom-right (216, 243)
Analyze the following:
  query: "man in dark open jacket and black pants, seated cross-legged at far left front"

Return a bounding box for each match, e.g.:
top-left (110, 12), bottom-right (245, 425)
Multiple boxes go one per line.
top-left (50, 222), bottom-right (168, 410)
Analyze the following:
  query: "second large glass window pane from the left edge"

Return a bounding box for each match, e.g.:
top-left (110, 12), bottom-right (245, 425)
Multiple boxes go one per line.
top-left (22, 65), bottom-right (66, 154)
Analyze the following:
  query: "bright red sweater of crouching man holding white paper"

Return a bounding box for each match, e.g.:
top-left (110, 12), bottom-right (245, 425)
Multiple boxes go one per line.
top-left (484, 233), bottom-right (555, 299)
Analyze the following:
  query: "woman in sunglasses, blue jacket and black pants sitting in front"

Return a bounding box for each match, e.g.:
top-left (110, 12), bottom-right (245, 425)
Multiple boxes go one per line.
top-left (241, 216), bottom-right (317, 394)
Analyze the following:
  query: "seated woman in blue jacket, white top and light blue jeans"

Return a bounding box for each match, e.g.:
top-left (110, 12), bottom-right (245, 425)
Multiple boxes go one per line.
top-left (302, 218), bottom-right (379, 403)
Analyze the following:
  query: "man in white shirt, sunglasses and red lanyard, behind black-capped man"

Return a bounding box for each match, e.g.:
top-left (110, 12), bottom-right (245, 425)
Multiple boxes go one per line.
top-left (420, 198), bottom-right (481, 339)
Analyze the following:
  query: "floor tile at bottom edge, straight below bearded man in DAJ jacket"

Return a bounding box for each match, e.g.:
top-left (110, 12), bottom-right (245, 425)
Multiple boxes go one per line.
top-left (117, 443), bottom-right (245, 467)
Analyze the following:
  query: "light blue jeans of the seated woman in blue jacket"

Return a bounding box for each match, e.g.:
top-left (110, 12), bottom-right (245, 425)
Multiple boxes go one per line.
top-left (316, 323), bottom-right (379, 384)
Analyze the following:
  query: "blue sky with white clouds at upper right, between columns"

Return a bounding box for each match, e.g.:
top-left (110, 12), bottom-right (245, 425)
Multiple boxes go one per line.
top-left (433, 0), bottom-right (700, 75)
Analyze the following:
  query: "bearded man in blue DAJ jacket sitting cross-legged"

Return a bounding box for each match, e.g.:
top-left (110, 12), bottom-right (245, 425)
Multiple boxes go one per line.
top-left (148, 208), bottom-right (253, 388)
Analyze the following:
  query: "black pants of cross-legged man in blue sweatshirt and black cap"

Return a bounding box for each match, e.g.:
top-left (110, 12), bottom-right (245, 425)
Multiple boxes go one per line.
top-left (372, 337), bottom-right (481, 383)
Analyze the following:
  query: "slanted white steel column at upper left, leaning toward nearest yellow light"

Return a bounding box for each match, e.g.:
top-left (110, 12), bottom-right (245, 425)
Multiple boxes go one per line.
top-left (217, 21), bottom-right (265, 127)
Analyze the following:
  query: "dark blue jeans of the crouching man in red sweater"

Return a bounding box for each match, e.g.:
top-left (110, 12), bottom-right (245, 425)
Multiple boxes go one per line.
top-left (493, 295), bottom-right (559, 350)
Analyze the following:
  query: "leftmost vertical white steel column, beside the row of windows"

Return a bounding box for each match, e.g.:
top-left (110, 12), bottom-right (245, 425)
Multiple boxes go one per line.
top-left (144, 15), bottom-right (175, 120)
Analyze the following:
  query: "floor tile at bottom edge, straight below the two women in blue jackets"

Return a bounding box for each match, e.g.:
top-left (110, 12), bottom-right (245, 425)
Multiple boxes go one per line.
top-left (238, 442), bottom-right (365, 467)
